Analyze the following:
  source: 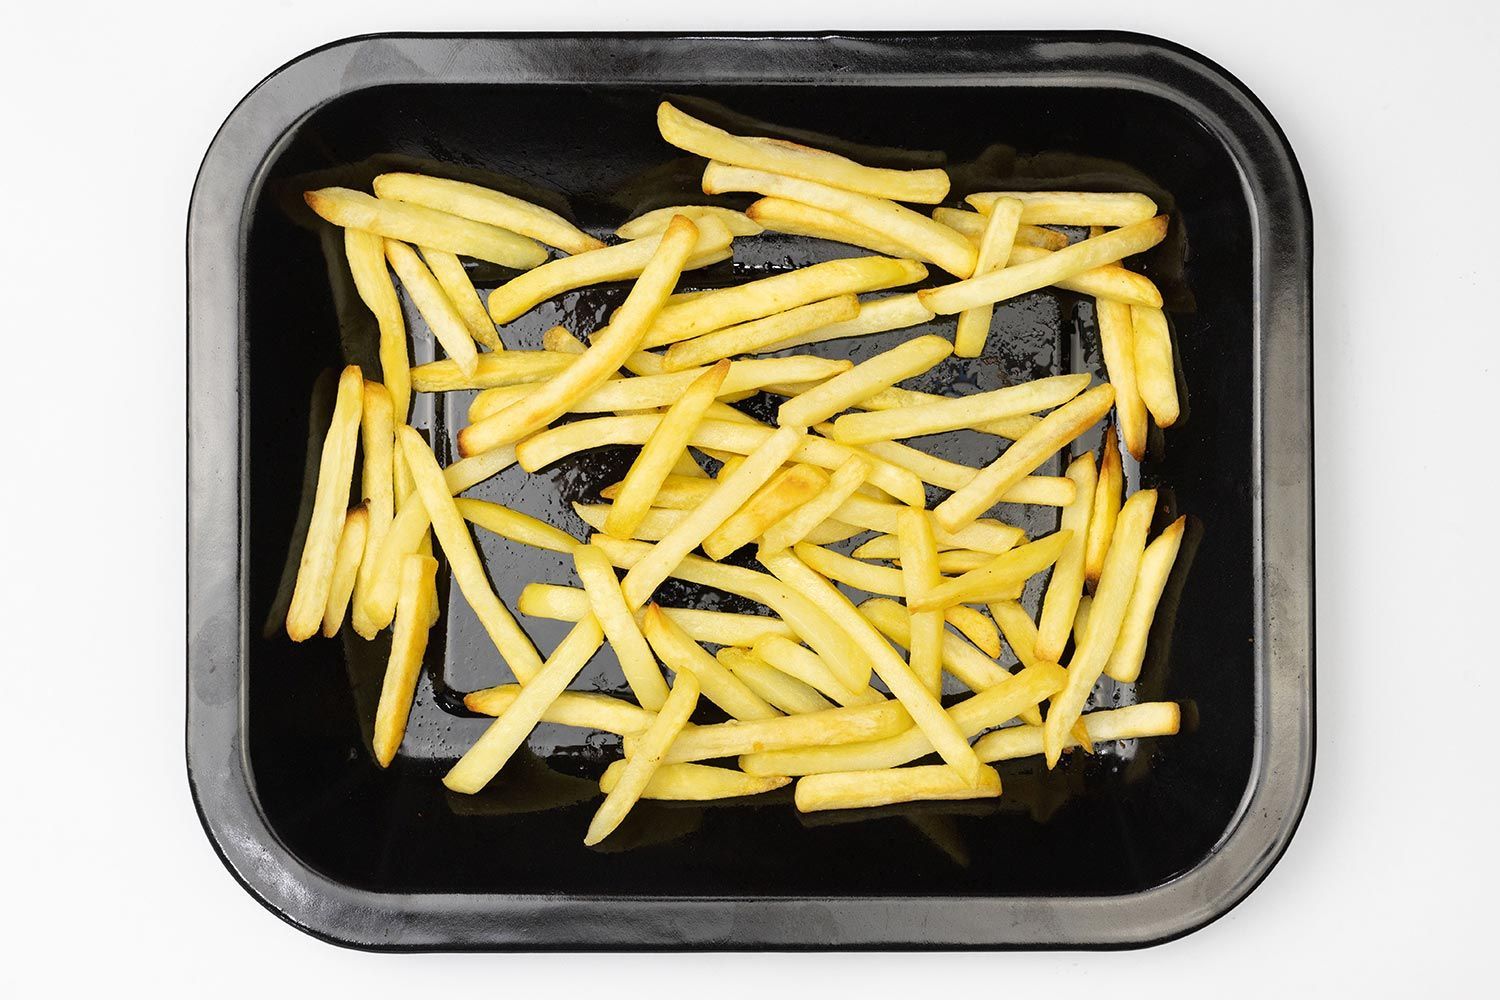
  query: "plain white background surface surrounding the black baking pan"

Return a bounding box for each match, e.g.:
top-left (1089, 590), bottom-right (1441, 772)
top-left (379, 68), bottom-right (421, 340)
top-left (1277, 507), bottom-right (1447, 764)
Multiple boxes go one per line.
top-left (0, 0), bottom-right (1500, 997)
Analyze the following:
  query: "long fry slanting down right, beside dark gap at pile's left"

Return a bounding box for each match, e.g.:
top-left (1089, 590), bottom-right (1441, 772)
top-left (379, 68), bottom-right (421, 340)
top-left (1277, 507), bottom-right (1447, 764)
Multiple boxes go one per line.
top-left (396, 427), bottom-right (542, 684)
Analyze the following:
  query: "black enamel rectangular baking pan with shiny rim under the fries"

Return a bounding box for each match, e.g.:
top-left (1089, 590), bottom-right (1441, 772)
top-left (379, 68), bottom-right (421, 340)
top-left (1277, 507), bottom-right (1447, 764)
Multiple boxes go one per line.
top-left (188, 33), bottom-right (1314, 949)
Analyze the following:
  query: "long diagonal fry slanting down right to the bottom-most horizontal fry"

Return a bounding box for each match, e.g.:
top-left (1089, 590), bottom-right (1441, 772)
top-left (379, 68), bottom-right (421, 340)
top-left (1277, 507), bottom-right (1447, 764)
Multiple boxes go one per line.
top-left (759, 552), bottom-right (981, 784)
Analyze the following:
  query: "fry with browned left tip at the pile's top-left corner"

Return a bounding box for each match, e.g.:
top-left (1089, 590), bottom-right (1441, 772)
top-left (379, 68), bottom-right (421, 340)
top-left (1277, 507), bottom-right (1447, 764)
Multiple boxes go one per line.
top-left (303, 187), bottom-right (548, 268)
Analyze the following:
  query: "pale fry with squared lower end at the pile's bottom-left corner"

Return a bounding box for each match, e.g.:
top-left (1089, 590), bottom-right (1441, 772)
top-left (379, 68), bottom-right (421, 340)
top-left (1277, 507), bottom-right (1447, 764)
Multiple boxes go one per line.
top-left (443, 615), bottom-right (605, 795)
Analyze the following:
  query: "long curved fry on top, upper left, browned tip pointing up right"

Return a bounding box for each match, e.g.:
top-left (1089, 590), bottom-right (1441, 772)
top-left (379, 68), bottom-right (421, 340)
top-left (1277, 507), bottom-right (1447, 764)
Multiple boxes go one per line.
top-left (459, 219), bottom-right (699, 456)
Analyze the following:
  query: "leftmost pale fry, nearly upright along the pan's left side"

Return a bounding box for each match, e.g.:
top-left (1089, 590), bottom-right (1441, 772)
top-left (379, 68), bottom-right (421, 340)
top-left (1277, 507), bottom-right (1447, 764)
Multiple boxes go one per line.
top-left (287, 364), bottom-right (365, 642)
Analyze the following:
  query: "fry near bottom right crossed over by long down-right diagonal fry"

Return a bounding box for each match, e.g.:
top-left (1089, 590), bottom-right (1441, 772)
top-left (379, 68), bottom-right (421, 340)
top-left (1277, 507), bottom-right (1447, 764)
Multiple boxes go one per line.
top-left (740, 664), bottom-right (1068, 777)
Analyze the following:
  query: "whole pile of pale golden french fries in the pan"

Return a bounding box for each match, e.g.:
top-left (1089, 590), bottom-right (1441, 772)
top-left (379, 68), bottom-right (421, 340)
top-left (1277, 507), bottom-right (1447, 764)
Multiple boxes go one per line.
top-left (287, 103), bottom-right (1184, 844)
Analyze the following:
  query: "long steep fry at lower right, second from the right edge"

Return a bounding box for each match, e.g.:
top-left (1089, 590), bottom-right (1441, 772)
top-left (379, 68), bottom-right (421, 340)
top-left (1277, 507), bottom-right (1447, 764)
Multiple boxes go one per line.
top-left (1043, 490), bottom-right (1157, 768)
